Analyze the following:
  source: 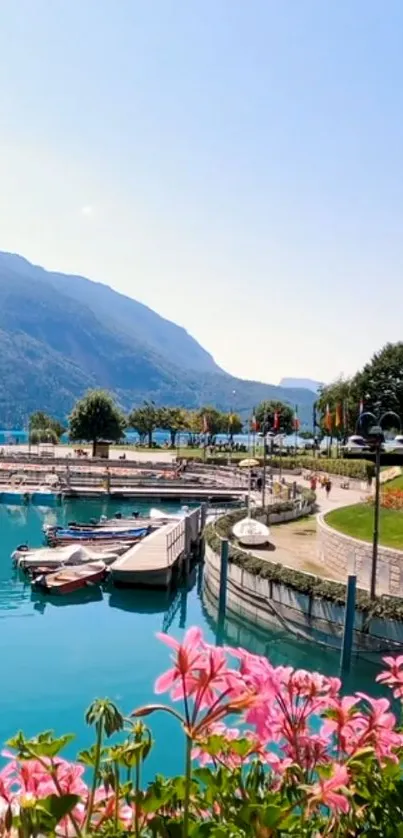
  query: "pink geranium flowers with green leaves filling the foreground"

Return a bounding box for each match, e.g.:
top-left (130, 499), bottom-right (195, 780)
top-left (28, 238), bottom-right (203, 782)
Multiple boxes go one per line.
top-left (0, 628), bottom-right (403, 838)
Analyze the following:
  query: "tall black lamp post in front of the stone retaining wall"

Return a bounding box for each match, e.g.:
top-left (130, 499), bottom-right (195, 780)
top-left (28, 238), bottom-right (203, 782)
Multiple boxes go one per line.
top-left (356, 410), bottom-right (401, 599)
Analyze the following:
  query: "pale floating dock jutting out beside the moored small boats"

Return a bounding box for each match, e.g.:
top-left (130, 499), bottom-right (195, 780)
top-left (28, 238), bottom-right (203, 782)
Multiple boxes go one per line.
top-left (110, 508), bottom-right (203, 588)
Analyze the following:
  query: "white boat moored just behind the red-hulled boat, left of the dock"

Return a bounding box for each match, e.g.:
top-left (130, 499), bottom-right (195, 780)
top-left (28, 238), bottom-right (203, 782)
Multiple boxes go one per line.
top-left (11, 544), bottom-right (119, 568)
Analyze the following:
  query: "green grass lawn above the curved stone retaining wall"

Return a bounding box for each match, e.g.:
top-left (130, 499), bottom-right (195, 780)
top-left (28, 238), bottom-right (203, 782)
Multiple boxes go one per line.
top-left (325, 506), bottom-right (403, 550)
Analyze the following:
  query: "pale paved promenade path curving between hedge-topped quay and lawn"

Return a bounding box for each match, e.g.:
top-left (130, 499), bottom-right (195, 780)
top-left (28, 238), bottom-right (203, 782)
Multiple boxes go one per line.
top-left (250, 478), bottom-right (366, 582)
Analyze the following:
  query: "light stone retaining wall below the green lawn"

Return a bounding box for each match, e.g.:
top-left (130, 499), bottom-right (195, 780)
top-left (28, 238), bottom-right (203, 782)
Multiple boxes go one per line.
top-left (317, 514), bottom-right (403, 596)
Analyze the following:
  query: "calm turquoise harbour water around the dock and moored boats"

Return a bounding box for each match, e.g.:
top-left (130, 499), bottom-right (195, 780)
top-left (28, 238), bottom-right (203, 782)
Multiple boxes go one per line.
top-left (0, 500), bottom-right (388, 778)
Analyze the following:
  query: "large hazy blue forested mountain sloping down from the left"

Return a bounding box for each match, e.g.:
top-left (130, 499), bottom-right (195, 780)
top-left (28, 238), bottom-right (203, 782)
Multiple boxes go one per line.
top-left (0, 252), bottom-right (314, 427)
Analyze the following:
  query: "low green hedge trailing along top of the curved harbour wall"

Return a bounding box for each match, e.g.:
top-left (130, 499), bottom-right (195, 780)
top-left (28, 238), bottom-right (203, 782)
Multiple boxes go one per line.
top-left (204, 512), bottom-right (403, 622)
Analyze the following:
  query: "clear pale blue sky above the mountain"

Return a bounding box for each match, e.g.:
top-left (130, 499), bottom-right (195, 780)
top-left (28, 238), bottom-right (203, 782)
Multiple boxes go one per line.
top-left (0, 0), bottom-right (403, 383)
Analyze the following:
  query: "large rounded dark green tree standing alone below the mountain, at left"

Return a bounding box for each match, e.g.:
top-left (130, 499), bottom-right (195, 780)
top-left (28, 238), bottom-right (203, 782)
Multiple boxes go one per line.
top-left (69, 390), bottom-right (126, 456)
